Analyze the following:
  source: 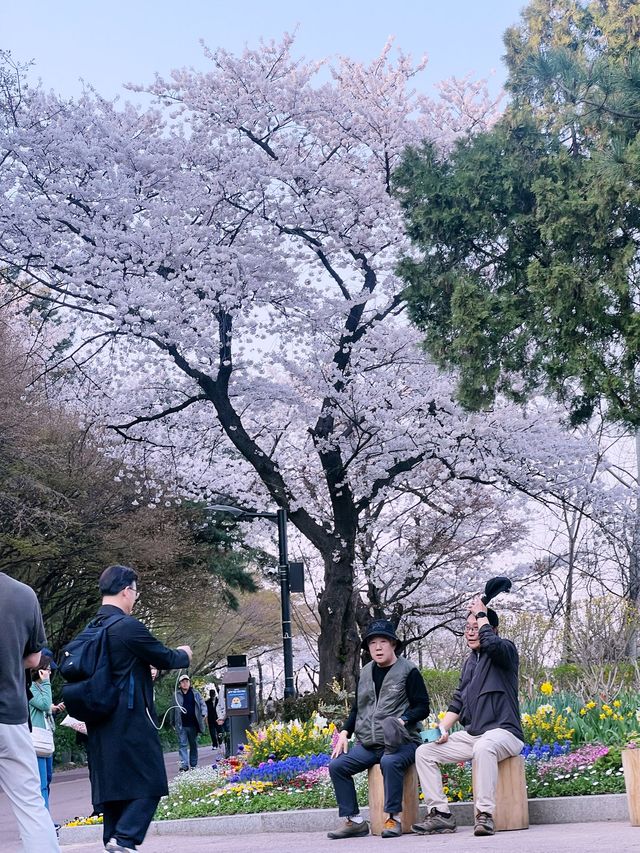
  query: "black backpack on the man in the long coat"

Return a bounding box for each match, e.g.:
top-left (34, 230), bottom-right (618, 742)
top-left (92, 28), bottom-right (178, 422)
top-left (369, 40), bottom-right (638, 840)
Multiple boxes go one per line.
top-left (59, 614), bottom-right (133, 723)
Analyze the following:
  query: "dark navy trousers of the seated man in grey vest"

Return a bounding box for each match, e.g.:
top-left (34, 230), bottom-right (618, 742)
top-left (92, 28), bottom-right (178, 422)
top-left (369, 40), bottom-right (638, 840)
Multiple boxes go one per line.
top-left (329, 743), bottom-right (418, 817)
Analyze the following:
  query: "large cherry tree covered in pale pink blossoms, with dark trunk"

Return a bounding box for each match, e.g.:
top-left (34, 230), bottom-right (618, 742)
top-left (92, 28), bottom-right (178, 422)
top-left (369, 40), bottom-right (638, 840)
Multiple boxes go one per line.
top-left (0, 37), bottom-right (608, 686)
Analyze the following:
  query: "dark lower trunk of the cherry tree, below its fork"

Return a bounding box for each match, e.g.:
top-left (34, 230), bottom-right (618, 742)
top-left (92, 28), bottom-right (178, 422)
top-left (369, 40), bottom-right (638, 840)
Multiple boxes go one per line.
top-left (318, 554), bottom-right (360, 693)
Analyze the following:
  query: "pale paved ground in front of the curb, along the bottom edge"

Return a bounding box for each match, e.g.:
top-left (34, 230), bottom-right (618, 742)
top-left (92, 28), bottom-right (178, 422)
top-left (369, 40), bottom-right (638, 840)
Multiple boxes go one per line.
top-left (60, 823), bottom-right (640, 853)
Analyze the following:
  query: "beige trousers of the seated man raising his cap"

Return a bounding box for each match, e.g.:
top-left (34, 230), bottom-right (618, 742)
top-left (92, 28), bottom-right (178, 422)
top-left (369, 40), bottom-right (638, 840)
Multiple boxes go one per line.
top-left (416, 729), bottom-right (524, 814)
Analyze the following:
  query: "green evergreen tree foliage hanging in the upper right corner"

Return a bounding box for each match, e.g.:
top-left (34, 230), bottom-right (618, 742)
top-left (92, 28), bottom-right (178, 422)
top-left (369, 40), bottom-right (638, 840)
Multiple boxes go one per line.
top-left (396, 0), bottom-right (640, 427)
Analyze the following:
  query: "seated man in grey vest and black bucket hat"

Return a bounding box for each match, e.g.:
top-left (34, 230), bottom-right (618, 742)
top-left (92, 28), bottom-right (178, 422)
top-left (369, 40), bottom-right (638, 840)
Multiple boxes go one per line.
top-left (328, 619), bottom-right (429, 838)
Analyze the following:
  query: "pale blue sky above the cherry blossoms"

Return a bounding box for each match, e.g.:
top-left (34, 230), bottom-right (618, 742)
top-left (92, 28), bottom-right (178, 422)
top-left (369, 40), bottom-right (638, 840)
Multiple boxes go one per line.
top-left (0, 0), bottom-right (525, 97)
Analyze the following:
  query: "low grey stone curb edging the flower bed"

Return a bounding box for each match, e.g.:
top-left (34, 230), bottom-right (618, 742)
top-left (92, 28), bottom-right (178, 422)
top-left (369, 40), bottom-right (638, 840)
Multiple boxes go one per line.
top-left (60, 794), bottom-right (629, 846)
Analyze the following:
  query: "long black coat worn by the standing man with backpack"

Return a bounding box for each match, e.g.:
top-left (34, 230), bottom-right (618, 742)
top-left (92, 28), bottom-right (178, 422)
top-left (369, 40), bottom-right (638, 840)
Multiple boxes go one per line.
top-left (87, 604), bottom-right (189, 803)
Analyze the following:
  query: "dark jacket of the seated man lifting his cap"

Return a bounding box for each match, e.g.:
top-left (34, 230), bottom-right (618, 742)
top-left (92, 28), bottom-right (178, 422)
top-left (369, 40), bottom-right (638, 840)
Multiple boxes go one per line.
top-left (447, 625), bottom-right (524, 740)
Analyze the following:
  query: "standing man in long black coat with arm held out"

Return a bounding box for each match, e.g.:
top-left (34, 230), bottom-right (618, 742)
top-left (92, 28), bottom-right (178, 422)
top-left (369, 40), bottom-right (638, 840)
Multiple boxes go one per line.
top-left (87, 566), bottom-right (191, 853)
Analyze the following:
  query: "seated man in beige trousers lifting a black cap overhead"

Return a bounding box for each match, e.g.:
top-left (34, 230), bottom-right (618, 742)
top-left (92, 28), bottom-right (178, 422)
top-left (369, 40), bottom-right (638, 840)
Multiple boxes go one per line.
top-left (413, 597), bottom-right (524, 835)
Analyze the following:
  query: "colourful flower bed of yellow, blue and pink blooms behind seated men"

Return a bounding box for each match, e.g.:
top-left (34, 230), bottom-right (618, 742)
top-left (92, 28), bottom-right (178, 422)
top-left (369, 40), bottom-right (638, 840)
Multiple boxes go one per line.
top-left (61, 696), bottom-right (640, 826)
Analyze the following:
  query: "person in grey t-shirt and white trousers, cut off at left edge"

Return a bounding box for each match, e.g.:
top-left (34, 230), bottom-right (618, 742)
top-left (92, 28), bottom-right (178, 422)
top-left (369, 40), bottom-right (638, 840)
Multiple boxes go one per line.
top-left (0, 572), bottom-right (60, 853)
